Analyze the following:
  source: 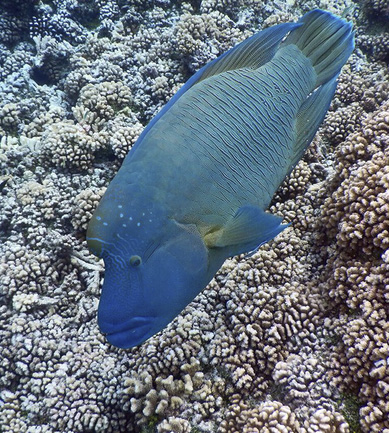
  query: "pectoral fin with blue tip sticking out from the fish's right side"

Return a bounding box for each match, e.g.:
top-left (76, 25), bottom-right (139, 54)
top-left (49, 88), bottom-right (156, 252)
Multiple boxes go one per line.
top-left (204, 206), bottom-right (288, 255)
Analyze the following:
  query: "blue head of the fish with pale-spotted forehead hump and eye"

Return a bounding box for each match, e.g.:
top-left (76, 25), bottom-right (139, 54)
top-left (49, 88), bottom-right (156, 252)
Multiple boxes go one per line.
top-left (87, 184), bottom-right (213, 348)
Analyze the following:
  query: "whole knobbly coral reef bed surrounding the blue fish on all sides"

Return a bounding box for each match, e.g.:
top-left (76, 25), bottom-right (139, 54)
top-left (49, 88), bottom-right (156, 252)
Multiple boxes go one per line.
top-left (0, 0), bottom-right (389, 433)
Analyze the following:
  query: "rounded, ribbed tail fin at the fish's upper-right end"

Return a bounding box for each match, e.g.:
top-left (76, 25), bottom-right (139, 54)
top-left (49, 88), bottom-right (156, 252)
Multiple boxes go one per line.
top-left (282, 9), bottom-right (354, 87)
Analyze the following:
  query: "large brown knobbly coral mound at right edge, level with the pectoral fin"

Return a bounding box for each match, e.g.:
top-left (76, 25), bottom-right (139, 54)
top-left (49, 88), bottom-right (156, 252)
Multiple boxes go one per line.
top-left (323, 101), bottom-right (389, 255)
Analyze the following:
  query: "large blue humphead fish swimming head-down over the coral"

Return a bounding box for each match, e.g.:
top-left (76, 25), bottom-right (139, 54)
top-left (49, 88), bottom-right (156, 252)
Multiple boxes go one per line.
top-left (87, 10), bottom-right (354, 348)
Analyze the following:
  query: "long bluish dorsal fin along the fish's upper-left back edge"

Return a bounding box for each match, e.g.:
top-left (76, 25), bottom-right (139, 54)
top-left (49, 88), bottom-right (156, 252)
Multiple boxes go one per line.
top-left (124, 23), bottom-right (302, 158)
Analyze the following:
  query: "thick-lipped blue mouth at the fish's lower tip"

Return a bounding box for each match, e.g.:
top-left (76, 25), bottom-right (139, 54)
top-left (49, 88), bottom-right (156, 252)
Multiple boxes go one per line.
top-left (99, 316), bottom-right (155, 349)
